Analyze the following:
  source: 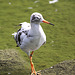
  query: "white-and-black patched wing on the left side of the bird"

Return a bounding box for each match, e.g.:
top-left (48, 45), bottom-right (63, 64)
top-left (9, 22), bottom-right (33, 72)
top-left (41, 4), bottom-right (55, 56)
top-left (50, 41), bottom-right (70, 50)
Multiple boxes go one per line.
top-left (12, 22), bottom-right (31, 47)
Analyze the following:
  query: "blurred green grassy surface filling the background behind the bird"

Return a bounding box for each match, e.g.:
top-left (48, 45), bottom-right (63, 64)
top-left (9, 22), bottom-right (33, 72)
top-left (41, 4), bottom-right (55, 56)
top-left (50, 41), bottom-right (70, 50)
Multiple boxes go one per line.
top-left (0, 0), bottom-right (75, 74)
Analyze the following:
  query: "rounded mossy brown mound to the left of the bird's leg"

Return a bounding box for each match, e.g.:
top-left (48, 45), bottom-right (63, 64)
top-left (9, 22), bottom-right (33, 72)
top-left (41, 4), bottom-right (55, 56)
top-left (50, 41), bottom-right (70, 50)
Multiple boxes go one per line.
top-left (0, 49), bottom-right (30, 75)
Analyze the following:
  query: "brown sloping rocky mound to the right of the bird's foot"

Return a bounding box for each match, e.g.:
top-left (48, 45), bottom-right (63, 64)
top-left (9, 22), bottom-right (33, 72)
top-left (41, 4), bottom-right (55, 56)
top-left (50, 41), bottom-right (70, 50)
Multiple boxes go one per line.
top-left (40, 60), bottom-right (75, 75)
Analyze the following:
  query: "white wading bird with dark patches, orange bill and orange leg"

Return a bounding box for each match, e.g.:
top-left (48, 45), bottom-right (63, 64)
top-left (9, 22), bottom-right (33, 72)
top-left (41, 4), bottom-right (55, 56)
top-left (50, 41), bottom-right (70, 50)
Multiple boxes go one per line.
top-left (12, 12), bottom-right (54, 75)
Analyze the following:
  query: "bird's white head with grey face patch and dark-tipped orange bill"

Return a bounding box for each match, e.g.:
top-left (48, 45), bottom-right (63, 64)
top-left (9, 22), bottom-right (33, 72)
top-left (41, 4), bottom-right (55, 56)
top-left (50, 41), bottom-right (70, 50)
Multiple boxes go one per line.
top-left (30, 12), bottom-right (54, 25)
